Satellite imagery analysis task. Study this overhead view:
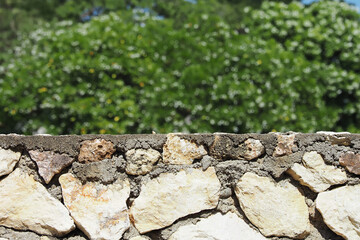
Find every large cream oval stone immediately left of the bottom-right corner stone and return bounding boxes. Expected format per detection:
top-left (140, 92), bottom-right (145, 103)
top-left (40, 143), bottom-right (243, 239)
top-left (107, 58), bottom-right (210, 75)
top-left (235, 172), bottom-right (310, 238)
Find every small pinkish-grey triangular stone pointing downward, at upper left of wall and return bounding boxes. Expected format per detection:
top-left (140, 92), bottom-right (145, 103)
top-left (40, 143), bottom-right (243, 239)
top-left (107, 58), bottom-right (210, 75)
top-left (29, 150), bottom-right (75, 183)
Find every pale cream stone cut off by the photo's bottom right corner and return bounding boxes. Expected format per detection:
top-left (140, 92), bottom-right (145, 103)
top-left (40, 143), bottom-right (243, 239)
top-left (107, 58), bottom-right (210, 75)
top-left (315, 185), bottom-right (360, 240)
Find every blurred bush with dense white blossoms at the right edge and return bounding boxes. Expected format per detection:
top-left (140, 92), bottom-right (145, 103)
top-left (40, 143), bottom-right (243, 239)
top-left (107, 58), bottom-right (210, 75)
top-left (244, 1), bottom-right (360, 131)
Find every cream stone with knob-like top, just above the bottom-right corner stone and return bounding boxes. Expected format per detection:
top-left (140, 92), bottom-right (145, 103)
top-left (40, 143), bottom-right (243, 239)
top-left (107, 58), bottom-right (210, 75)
top-left (288, 151), bottom-right (347, 192)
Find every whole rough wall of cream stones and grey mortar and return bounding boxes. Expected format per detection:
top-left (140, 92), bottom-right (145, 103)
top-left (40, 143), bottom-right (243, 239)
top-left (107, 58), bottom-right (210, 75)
top-left (0, 132), bottom-right (360, 240)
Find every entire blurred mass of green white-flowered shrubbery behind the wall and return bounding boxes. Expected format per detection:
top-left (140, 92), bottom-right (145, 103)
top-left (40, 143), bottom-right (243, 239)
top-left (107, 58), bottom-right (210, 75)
top-left (0, 0), bottom-right (360, 134)
